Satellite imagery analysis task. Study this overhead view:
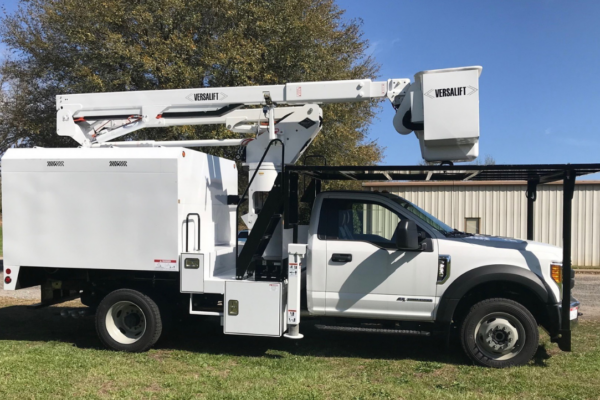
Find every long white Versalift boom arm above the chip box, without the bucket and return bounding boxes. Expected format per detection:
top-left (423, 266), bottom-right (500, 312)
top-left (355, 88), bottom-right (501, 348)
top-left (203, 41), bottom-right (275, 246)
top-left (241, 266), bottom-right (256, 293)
top-left (57, 79), bottom-right (410, 146)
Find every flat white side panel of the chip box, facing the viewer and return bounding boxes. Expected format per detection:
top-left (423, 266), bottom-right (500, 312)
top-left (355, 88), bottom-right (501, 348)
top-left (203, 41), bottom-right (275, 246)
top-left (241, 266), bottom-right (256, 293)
top-left (3, 149), bottom-right (179, 271)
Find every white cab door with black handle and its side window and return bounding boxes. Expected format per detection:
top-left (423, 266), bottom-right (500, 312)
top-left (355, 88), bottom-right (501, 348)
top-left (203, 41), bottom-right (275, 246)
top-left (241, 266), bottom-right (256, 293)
top-left (319, 194), bottom-right (438, 320)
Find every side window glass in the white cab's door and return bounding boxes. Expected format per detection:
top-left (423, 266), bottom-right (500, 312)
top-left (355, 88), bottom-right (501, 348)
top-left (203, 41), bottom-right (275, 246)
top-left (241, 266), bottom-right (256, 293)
top-left (317, 199), bottom-right (418, 248)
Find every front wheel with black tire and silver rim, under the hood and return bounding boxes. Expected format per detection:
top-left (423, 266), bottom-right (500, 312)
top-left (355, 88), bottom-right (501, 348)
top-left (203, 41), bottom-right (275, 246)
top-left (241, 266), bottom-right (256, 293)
top-left (461, 298), bottom-right (540, 368)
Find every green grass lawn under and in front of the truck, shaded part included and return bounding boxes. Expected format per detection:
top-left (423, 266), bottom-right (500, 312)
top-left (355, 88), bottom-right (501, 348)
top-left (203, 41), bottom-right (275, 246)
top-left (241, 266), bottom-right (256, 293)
top-left (0, 298), bottom-right (600, 399)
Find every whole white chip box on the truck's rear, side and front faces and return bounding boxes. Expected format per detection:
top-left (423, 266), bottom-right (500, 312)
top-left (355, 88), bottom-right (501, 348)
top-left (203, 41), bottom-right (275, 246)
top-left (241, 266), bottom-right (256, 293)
top-left (2, 147), bottom-right (237, 271)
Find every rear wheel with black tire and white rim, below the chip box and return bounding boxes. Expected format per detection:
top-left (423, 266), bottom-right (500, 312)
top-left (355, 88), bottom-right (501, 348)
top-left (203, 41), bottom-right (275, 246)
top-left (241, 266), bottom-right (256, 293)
top-left (96, 289), bottom-right (162, 353)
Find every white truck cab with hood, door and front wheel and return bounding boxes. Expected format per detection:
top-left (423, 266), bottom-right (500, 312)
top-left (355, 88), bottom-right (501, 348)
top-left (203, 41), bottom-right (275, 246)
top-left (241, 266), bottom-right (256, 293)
top-left (306, 191), bottom-right (577, 366)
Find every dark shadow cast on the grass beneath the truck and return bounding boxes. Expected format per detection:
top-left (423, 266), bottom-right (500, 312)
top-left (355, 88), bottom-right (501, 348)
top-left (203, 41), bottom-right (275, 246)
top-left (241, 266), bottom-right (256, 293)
top-left (0, 306), bottom-right (550, 366)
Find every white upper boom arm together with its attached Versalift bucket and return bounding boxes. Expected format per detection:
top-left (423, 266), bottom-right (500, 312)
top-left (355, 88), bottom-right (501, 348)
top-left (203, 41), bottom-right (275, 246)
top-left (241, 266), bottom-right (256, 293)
top-left (56, 67), bottom-right (482, 162)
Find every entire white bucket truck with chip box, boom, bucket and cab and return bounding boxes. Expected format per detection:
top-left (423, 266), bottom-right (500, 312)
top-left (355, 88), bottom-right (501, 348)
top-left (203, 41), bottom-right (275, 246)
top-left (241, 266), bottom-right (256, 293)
top-left (2, 67), bottom-right (577, 367)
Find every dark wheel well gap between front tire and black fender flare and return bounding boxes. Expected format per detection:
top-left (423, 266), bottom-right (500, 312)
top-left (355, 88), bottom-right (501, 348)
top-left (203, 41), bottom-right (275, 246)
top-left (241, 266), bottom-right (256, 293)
top-left (452, 281), bottom-right (548, 325)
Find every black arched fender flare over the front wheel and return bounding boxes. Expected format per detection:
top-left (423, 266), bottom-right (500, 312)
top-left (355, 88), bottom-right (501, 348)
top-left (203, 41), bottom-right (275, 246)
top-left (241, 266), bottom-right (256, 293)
top-left (436, 265), bottom-right (554, 323)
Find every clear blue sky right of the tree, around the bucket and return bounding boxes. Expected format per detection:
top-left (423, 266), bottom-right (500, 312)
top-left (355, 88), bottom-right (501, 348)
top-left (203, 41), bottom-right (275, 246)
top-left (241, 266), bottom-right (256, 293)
top-left (2, 0), bottom-right (600, 175)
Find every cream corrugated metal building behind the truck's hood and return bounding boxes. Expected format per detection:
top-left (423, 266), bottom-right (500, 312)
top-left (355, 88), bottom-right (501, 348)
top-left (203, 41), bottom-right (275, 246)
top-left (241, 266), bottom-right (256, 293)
top-left (363, 181), bottom-right (600, 267)
